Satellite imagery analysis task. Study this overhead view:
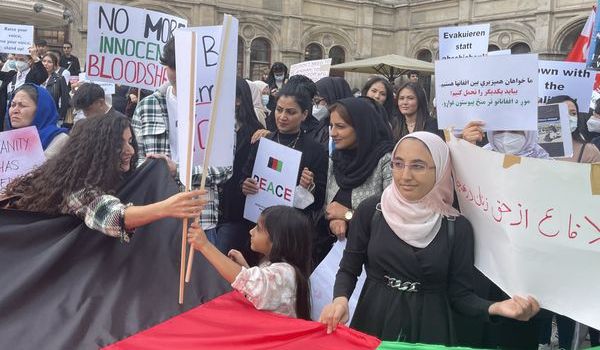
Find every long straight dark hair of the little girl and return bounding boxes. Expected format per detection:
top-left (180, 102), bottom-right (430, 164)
top-left (261, 205), bottom-right (313, 320)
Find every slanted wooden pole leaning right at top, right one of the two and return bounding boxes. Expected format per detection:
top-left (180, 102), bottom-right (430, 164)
top-left (185, 14), bottom-right (232, 282)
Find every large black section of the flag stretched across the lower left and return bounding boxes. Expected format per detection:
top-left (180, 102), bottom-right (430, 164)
top-left (0, 160), bottom-right (231, 350)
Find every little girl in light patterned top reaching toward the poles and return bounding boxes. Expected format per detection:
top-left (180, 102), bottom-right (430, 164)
top-left (188, 206), bottom-right (312, 320)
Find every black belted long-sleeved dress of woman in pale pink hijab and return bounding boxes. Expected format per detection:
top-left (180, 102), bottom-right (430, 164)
top-left (334, 196), bottom-right (491, 345)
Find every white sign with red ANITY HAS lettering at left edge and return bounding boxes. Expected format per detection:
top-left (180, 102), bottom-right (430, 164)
top-left (0, 126), bottom-right (46, 192)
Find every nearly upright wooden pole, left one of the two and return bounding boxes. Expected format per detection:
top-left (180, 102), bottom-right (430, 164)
top-left (179, 32), bottom-right (196, 304)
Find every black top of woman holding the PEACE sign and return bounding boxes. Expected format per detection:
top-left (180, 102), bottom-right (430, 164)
top-left (240, 131), bottom-right (329, 216)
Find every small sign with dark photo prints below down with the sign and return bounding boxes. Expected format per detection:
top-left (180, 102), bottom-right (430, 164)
top-left (537, 103), bottom-right (573, 157)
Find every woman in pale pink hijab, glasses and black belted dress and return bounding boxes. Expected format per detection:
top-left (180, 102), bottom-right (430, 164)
top-left (320, 132), bottom-right (539, 345)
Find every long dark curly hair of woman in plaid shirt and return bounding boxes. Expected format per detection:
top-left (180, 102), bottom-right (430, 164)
top-left (5, 113), bottom-right (137, 215)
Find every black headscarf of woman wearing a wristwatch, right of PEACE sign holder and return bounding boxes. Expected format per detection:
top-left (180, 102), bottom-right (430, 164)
top-left (332, 97), bottom-right (394, 190)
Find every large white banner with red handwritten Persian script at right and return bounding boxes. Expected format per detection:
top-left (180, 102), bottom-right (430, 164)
top-left (449, 133), bottom-right (600, 328)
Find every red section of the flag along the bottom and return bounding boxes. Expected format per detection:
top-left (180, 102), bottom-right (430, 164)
top-left (104, 291), bottom-right (381, 350)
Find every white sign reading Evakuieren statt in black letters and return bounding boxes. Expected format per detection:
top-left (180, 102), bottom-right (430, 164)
top-left (439, 23), bottom-right (490, 60)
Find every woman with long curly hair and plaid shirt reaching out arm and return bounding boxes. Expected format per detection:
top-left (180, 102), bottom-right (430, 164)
top-left (0, 115), bottom-right (205, 242)
